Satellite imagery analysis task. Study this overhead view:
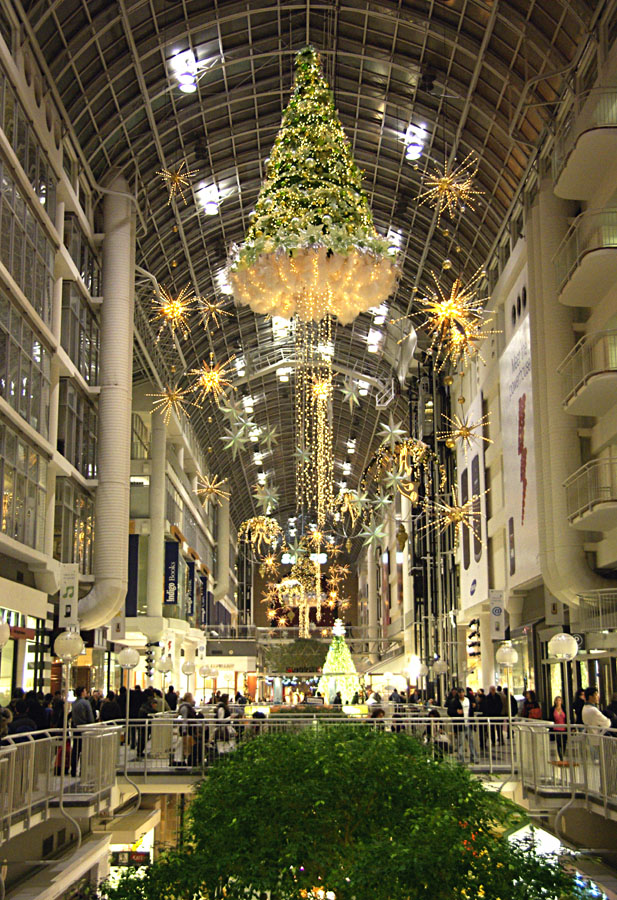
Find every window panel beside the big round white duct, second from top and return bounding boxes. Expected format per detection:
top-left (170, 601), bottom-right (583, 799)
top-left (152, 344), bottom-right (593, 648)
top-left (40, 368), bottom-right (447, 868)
top-left (61, 281), bottom-right (99, 385)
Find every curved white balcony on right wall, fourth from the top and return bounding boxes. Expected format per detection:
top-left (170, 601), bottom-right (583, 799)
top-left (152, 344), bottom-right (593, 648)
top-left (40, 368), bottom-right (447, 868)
top-left (564, 459), bottom-right (617, 532)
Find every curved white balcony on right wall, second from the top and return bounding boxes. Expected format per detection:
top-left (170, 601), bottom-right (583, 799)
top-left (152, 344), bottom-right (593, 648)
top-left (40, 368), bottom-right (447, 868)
top-left (553, 208), bottom-right (617, 306)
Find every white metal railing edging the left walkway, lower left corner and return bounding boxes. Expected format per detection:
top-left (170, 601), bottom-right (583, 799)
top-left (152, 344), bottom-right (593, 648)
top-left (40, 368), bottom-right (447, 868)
top-left (0, 725), bottom-right (122, 839)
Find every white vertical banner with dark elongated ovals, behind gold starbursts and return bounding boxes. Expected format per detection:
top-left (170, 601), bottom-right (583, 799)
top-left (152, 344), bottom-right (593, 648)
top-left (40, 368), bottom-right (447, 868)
top-left (456, 391), bottom-right (488, 610)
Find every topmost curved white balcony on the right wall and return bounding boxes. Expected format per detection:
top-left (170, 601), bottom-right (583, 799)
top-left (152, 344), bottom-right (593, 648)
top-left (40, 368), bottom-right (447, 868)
top-left (553, 87), bottom-right (617, 200)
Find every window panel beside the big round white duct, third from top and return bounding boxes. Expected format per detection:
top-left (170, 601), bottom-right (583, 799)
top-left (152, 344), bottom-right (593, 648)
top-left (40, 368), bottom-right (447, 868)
top-left (58, 378), bottom-right (98, 478)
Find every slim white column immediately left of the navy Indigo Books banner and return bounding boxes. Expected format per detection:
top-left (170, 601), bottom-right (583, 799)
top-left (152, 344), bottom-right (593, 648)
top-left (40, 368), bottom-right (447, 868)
top-left (146, 412), bottom-right (167, 616)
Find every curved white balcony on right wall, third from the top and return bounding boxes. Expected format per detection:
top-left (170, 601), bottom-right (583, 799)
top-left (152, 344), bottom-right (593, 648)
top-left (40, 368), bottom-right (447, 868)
top-left (558, 330), bottom-right (617, 416)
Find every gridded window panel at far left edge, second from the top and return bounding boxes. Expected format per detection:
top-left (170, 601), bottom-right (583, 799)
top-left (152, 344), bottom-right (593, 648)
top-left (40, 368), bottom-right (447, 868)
top-left (0, 157), bottom-right (54, 325)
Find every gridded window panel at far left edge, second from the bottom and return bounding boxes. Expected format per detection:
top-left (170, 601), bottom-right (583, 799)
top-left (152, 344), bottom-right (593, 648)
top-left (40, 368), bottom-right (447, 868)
top-left (0, 286), bottom-right (51, 437)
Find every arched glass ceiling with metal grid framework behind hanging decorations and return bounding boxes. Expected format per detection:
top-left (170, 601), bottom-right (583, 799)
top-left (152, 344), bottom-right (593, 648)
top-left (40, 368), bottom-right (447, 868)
top-left (21, 0), bottom-right (606, 523)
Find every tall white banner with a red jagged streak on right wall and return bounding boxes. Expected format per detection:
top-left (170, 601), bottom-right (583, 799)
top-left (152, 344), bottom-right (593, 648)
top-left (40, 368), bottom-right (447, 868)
top-left (499, 316), bottom-right (540, 587)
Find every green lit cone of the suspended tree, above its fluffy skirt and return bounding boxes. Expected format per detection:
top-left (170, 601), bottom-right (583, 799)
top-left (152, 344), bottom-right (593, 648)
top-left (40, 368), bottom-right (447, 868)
top-left (229, 47), bottom-right (389, 267)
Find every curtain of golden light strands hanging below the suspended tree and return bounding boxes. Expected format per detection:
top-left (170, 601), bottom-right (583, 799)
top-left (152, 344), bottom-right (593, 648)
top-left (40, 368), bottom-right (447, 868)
top-left (294, 316), bottom-right (334, 529)
